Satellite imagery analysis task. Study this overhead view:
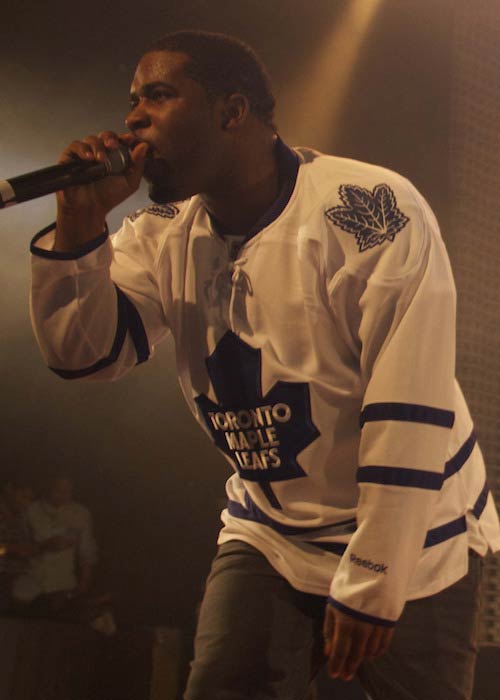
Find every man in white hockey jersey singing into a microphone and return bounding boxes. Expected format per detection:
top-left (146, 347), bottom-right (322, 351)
top-left (32, 31), bottom-right (500, 700)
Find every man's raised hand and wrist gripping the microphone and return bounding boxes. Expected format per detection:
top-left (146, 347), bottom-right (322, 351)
top-left (54, 131), bottom-right (149, 252)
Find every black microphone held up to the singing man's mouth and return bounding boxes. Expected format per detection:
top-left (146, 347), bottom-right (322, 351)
top-left (0, 144), bottom-right (131, 209)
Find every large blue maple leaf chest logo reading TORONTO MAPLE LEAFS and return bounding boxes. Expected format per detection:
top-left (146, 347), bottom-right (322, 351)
top-left (195, 331), bottom-right (320, 482)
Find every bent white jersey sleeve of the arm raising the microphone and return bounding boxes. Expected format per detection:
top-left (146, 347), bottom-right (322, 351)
top-left (30, 215), bottom-right (168, 380)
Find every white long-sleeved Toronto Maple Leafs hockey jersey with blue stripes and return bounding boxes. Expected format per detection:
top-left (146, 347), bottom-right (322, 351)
top-left (32, 143), bottom-right (500, 626)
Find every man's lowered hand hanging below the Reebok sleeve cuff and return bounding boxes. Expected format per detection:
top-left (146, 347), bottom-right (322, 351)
top-left (323, 605), bottom-right (394, 681)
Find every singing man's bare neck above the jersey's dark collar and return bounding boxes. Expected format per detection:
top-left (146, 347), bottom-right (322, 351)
top-left (201, 133), bottom-right (279, 235)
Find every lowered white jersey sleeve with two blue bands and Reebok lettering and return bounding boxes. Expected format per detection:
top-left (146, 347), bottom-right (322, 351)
top-left (329, 183), bottom-right (455, 626)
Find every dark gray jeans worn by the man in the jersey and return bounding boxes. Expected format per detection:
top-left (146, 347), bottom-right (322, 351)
top-left (184, 541), bottom-right (482, 700)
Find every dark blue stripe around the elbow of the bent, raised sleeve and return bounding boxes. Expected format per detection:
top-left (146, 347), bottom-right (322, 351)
top-left (50, 285), bottom-right (149, 379)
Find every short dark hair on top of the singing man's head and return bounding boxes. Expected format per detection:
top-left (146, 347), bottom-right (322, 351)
top-left (146, 30), bottom-right (275, 126)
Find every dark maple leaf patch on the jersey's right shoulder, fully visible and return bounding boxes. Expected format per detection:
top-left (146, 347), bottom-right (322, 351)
top-left (325, 184), bottom-right (410, 253)
